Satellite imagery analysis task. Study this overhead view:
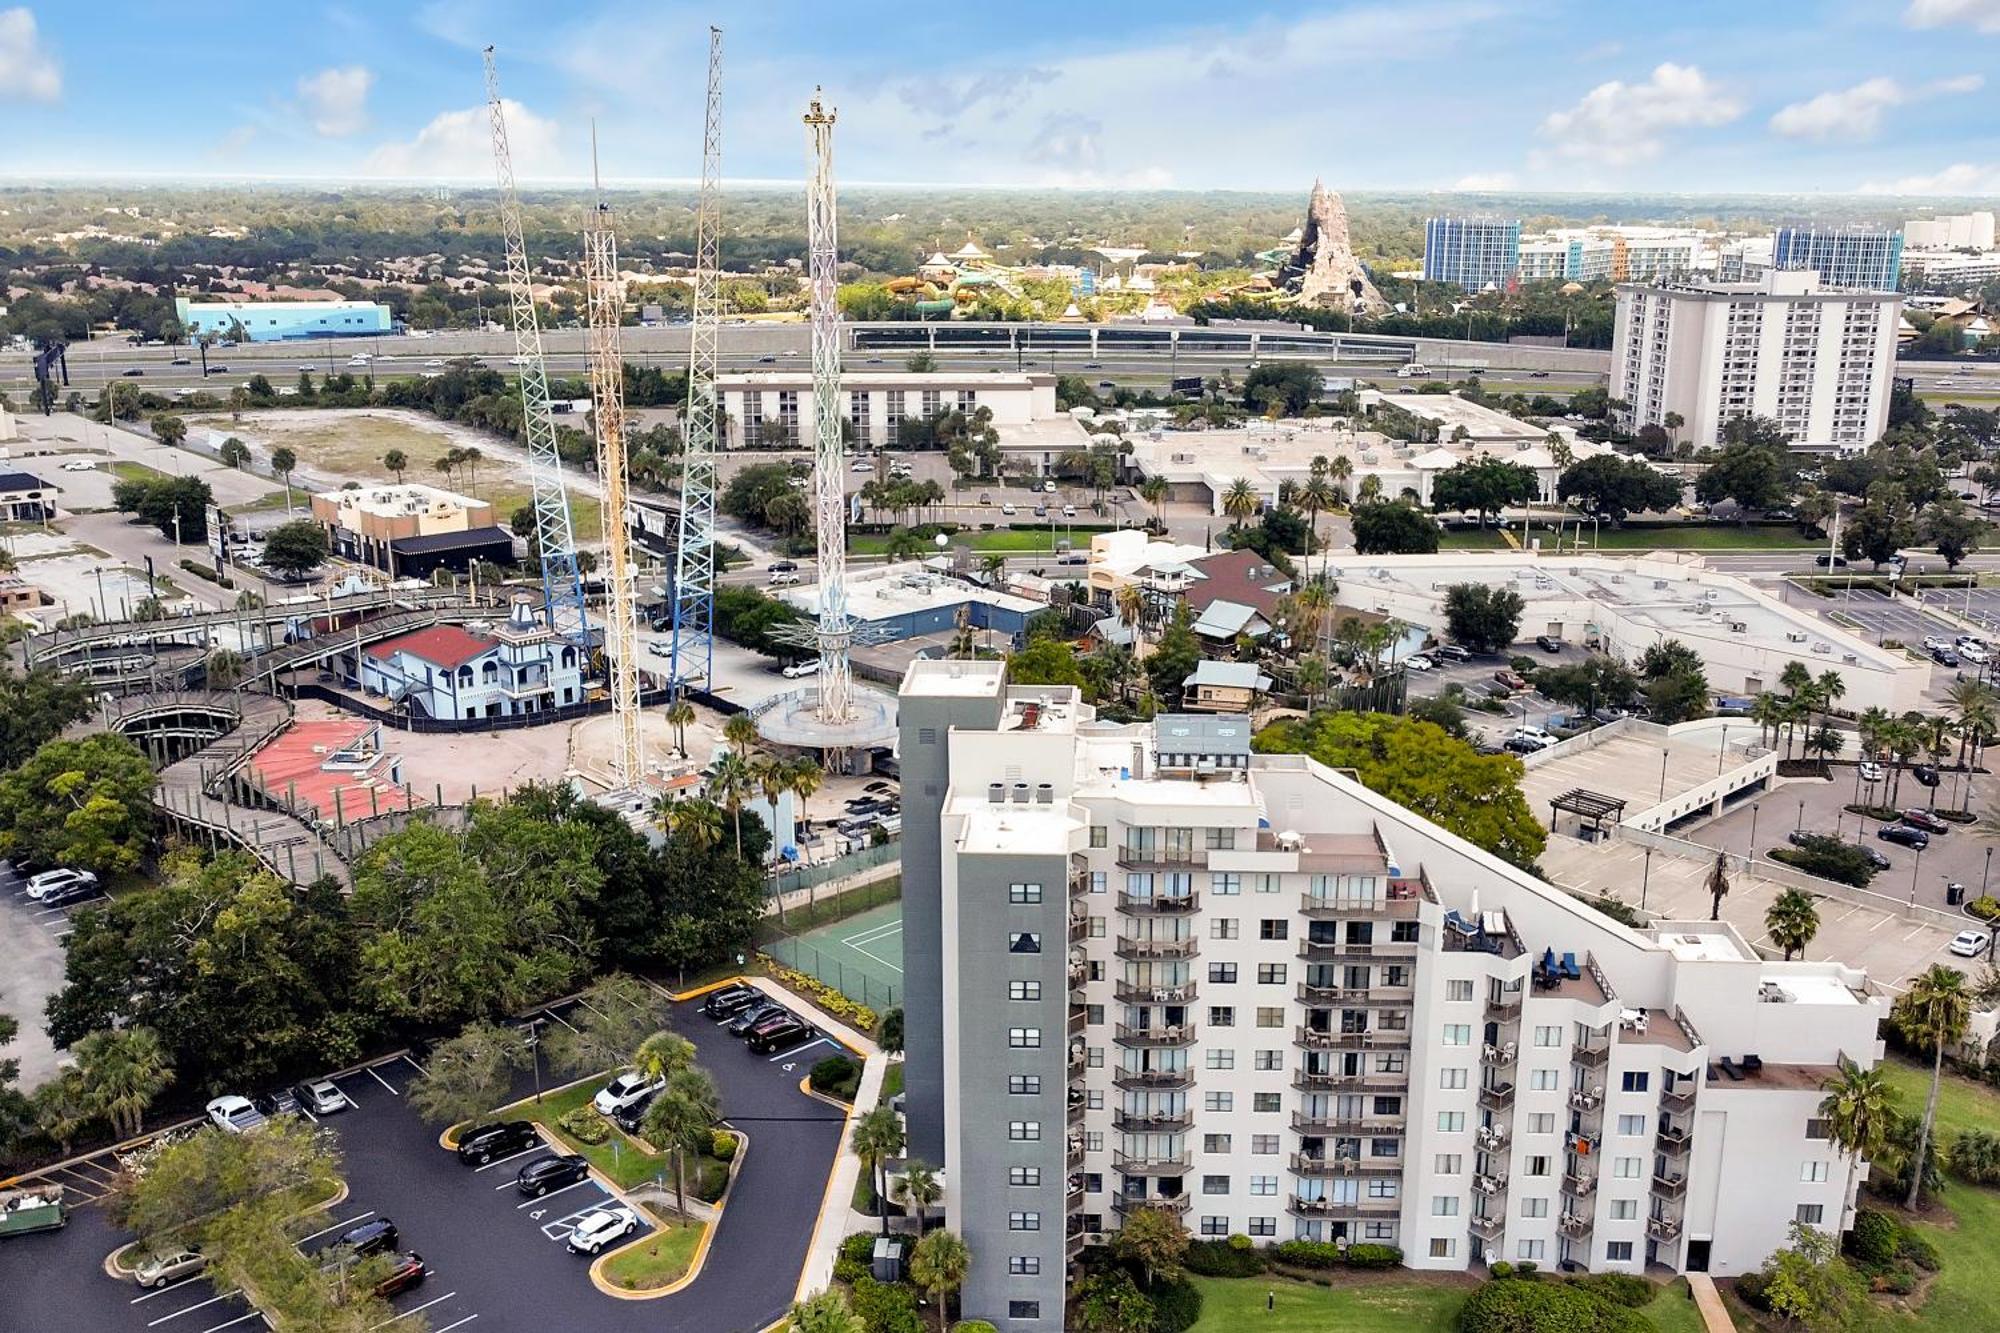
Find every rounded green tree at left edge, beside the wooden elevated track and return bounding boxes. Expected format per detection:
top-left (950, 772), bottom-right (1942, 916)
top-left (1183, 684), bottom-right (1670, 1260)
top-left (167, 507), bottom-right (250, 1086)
top-left (0, 733), bottom-right (156, 875)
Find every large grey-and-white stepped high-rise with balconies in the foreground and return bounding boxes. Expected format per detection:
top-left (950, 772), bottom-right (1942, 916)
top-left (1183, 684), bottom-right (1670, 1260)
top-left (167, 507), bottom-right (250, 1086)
top-left (900, 660), bottom-right (1882, 1331)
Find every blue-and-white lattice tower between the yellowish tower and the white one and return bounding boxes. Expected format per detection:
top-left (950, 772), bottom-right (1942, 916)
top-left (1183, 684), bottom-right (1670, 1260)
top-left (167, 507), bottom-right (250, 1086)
top-left (668, 28), bottom-right (722, 691)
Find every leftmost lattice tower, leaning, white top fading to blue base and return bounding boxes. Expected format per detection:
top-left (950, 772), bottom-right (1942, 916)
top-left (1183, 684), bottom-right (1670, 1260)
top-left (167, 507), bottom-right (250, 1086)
top-left (486, 46), bottom-right (584, 642)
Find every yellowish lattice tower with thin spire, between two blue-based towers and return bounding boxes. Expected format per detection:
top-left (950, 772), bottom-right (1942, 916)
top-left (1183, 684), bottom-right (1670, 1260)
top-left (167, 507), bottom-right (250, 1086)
top-left (584, 126), bottom-right (644, 789)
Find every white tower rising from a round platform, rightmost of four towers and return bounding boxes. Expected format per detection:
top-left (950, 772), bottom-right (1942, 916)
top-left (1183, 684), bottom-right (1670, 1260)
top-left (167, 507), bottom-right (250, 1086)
top-left (806, 88), bottom-right (854, 723)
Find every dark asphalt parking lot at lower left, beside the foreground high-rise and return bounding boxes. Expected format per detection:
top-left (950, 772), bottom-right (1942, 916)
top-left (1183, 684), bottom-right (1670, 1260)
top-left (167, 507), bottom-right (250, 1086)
top-left (0, 980), bottom-right (844, 1333)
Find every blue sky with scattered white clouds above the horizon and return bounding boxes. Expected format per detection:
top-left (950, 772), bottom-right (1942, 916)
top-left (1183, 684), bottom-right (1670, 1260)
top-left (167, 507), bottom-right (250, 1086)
top-left (0, 0), bottom-right (2000, 194)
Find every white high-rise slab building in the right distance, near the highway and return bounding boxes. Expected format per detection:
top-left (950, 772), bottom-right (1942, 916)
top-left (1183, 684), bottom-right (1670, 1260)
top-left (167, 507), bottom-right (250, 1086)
top-left (1610, 272), bottom-right (1902, 448)
